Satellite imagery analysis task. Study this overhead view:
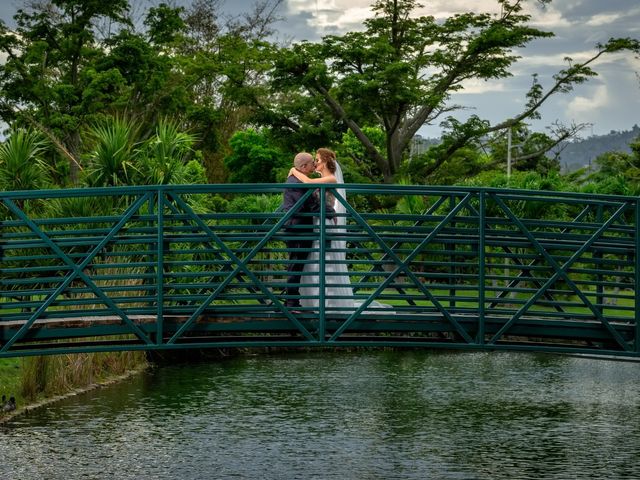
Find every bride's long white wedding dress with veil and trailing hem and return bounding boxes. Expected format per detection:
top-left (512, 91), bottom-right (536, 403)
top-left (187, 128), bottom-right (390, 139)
top-left (300, 162), bottom-right (391, 313)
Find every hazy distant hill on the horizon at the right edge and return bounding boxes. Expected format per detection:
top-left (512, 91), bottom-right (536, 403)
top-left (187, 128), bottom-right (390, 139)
top-left (560, 125), bottom-right (640, 172)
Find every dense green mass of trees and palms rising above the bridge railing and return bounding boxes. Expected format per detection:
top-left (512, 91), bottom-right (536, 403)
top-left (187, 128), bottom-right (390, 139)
top-left (0, 0), bottom-right (639, 189)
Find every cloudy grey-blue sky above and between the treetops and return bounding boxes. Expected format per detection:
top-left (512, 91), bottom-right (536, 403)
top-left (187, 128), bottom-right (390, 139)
top-left (0, 0), bottom-right (640, 137)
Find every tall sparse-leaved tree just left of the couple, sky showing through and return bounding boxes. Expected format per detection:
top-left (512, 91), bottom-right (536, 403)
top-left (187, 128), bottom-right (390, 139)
top-left (181, 0), bottom-right (284, 182)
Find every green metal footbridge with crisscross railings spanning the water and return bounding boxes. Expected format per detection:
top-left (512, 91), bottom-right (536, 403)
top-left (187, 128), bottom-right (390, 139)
top-left (0, 184), bottom-right (640, 357)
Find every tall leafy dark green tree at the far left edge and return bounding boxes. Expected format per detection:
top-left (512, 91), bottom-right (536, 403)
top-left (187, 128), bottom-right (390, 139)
top-left (0, 0), bottom-right (129, 182)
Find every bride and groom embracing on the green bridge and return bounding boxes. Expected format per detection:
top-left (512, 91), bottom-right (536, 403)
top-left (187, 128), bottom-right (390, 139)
top-left (283, 148), bottom-right (386, 313)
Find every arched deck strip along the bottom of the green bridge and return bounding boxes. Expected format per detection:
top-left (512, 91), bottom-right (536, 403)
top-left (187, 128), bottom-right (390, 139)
top-left (0, 313), bottom-right (635, 355)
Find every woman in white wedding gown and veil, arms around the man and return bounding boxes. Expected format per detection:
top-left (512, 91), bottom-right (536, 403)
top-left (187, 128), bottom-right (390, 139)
top-left (289, 148), bottom-right (390, 313)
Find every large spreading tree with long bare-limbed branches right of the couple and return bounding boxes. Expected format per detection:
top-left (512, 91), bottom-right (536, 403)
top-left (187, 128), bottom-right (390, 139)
top-left (274, 0), bottom-right (640, 181)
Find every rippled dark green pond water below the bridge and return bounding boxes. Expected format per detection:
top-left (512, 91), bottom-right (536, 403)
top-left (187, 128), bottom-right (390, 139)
top-left (0, 351), bottom-right (640, 479)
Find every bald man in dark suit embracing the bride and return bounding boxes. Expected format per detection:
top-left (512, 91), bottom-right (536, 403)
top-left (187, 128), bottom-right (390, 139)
top-left (282, 152), bottom-right (320, 308)
